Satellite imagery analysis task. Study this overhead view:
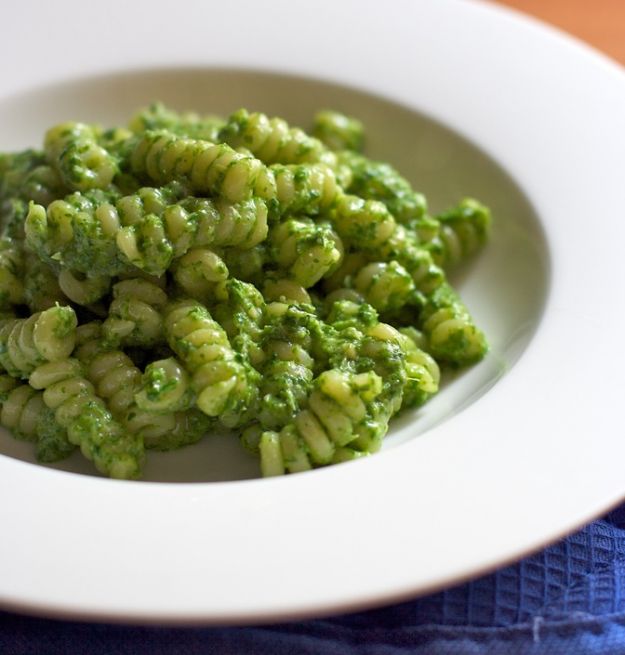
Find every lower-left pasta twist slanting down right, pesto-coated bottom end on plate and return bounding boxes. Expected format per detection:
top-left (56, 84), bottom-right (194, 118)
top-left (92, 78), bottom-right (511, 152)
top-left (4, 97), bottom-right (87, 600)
top-left (29, 358), bottom-right (144, 479)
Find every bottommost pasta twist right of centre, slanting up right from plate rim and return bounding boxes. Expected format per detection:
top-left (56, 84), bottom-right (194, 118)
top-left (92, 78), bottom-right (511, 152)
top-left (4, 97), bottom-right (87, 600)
top-left (259, 369), bottom-right (386, 476)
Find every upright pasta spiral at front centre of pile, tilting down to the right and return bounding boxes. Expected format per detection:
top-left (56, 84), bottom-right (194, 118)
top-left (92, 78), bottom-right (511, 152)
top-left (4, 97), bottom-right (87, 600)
top-left (164, 300), bottom-right (258, 427)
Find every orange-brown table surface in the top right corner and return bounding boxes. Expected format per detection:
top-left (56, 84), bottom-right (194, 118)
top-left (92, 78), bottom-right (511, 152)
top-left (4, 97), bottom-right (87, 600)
top-left (498, 0), bottom-right (625, 64)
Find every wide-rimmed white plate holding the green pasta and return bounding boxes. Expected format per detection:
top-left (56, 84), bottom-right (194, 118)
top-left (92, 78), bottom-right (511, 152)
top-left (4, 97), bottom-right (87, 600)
top-left (0, 0), bottom-right (625, 623)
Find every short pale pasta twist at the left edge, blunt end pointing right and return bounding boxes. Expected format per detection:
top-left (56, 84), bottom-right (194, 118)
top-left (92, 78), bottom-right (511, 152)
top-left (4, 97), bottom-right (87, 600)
top-left (0, 306), bottom-right (77, 378)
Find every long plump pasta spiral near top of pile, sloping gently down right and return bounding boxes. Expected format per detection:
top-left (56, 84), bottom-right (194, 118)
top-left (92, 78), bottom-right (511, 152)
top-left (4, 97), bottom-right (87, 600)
top-left (130, 130), bottom-right (276, 203)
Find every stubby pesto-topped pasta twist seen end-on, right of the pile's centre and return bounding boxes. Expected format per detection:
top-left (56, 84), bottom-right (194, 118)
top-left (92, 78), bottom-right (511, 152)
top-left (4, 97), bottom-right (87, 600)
top-left (269, 218), bottom-right (343, 288)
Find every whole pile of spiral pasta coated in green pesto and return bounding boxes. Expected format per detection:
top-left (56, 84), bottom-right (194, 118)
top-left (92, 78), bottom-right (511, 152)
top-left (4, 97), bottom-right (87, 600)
top-left (0, 103), bottom-right (491, 479)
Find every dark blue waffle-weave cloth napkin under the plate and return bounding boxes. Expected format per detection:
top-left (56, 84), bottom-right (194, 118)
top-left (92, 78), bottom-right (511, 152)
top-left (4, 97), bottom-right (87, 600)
top-left (6, 505), bottom-right (625, 655)
